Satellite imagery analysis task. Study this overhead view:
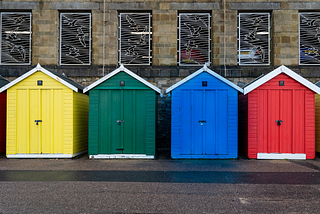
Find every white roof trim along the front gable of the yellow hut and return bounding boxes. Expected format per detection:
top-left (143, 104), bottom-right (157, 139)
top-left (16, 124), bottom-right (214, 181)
top-left (0, 63), bottom-right (78, 93)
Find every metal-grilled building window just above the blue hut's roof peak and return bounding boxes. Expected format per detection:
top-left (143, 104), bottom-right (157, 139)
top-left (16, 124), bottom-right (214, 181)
top-left (178, 13), bottom-right (211, 66)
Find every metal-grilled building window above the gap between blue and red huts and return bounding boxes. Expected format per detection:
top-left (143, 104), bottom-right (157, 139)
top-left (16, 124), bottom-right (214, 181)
top-left (238, 13), bottom-right (270, 65)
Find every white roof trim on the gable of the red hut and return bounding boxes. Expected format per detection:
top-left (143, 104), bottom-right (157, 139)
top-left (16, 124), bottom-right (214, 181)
top-left (244, 65), bottom-right (320, 94)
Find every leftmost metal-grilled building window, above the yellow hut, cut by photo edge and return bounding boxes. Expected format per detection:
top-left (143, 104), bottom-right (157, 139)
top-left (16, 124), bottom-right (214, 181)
top-left (0, 12), bottom-right (32, 65)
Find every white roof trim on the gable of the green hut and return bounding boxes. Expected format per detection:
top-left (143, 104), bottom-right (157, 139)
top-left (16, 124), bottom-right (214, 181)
top-left (83, 64), bottom-right (161, 94)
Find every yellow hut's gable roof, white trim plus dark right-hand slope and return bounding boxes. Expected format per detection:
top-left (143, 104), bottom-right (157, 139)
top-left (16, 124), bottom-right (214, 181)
top-left (0, 63), bottom-right (83, 92)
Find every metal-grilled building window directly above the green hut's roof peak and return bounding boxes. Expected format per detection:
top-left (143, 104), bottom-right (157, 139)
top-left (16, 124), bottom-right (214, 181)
top-left (119, 13), bottom-right (152, 65)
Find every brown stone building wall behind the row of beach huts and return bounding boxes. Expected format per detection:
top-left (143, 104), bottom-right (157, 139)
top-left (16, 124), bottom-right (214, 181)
top-left (0, 0), bottom-right (320, 148)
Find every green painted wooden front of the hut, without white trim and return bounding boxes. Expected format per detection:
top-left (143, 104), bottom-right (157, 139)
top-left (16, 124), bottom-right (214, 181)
top-left (89, 72), bottom-right (156, 155)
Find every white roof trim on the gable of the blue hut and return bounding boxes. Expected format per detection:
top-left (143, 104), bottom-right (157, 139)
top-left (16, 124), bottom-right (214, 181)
top-left (166, 64), bottom-right (243, 94)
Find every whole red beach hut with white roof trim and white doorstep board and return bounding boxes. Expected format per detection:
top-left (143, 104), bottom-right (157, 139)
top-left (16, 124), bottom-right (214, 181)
top-left (239, 65), bottom-right (320, 159)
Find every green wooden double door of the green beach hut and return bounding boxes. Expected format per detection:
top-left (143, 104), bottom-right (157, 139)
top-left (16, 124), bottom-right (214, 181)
top-left (98, 90), bottom-right (146, 154)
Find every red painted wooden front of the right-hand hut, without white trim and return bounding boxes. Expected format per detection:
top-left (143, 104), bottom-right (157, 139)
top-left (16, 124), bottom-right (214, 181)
top-left (245, 74), bottom-right (315, 159)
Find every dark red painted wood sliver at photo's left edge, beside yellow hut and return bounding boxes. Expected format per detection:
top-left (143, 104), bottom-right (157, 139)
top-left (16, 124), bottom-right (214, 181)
top-left (0, 92), bottom-right (7, 153)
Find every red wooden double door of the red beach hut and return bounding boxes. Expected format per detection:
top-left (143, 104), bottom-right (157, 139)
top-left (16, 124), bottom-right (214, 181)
top-left (258, 89), bottom-right (305, 153)
